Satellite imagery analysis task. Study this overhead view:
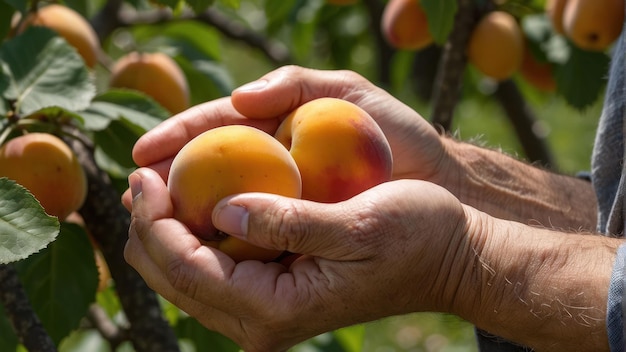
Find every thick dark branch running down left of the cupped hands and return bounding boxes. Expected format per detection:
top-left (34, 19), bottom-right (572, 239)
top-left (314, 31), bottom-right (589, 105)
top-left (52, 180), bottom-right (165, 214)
top-left (70, 140), bottom-right (179, 352)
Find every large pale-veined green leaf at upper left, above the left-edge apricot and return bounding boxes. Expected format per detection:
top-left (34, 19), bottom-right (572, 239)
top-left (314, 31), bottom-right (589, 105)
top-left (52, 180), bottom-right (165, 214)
top-left (0, 26), bottom-right (95, 114)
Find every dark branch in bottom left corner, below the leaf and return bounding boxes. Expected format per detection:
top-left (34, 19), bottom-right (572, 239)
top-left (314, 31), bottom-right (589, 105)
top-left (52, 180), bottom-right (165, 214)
top-left (0, 264), bottom-right (57, 352)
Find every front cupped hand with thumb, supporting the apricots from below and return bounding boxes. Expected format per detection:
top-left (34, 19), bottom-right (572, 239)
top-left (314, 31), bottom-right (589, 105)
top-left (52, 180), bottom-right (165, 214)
top-left (124, 168), bottom-right (471, 352)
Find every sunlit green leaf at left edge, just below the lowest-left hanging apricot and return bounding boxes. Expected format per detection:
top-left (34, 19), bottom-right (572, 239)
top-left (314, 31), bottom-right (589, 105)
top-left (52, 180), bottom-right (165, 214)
top-left (0, 177), bottom-right (59, 264)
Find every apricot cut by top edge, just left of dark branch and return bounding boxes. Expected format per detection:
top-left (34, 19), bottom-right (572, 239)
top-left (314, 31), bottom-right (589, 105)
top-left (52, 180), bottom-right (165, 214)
top-left (381, 0), bottom-right (433, 50)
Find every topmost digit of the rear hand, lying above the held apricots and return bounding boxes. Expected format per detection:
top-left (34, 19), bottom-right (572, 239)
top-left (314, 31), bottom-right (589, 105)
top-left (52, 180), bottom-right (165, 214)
top-left (232, 66), bottom-right (369, 119)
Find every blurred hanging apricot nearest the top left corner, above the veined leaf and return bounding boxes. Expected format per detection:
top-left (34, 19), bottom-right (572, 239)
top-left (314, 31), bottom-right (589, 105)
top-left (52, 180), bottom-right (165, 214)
top-left (17, 4), bottom-right (100, 68)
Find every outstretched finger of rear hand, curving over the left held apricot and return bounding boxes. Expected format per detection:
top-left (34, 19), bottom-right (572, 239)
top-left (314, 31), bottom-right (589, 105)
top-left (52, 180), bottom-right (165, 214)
top-left (132, 98), bottom-right (278, 166)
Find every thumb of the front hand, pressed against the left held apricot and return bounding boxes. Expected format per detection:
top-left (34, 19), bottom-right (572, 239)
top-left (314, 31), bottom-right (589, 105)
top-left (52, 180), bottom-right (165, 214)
top-left (212, 193), bottom-right (360, 260)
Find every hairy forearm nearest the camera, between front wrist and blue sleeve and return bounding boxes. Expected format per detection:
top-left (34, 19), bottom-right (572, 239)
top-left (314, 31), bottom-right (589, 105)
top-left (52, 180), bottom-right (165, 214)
top-left (455, 207), bottom-right (623, 351)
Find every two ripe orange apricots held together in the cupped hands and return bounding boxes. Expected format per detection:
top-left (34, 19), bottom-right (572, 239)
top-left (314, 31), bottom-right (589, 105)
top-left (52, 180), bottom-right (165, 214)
top-left (167, 98), bottom-right (392, 262)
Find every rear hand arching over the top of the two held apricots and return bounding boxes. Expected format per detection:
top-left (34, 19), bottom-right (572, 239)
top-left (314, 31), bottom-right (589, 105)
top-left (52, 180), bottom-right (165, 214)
top-left (123, 66), bottom-right (445, 209)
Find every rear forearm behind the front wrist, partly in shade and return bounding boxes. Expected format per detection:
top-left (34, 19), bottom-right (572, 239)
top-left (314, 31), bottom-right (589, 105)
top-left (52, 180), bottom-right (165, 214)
top-left (441, 138), bottom-right (597, 231)
